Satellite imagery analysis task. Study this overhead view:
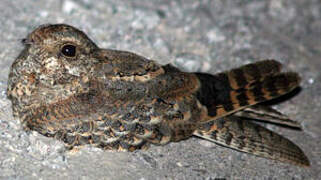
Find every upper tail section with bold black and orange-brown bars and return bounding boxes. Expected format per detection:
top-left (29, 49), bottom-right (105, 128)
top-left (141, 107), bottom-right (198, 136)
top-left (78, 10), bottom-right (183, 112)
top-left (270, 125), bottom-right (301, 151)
top-left (196, 60), bottom-right (300, 119)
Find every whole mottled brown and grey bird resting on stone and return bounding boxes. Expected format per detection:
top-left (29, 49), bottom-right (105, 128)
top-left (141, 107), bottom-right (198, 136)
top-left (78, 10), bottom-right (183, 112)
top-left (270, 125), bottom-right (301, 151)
top-left (7, 24), bottom-right (309, 165)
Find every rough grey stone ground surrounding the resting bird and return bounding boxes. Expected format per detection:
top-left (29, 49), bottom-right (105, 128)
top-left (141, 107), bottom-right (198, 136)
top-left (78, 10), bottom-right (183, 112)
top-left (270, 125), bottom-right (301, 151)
top-left (0, 0), bottom-right (321, 179)
